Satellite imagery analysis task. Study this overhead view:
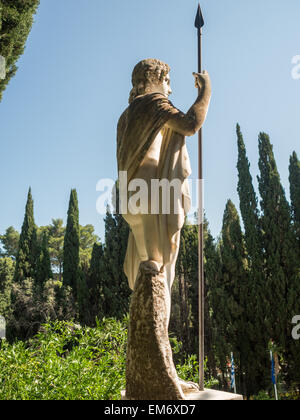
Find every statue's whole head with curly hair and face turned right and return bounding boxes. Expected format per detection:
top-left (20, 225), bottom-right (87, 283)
top-left (129, 58), bottom-right (172, 103)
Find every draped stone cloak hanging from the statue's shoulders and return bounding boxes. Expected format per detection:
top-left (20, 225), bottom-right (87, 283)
top-left (117, 93), bottom-right (191, 290)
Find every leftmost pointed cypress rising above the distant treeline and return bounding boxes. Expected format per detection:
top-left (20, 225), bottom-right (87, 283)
top-left (14, 188), bottom-right (38, 283)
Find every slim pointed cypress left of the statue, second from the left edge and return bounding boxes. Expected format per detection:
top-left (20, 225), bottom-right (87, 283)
top-left (63, 189), bottom-right (80, 297)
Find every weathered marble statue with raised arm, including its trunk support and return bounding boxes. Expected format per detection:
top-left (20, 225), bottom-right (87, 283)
top-left (117, 59), bottom-right (211, 400)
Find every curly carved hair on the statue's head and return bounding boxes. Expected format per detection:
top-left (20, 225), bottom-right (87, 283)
top-left (129, 58), bottom-right (170, 103)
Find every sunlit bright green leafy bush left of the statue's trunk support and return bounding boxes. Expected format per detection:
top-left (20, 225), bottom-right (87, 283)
top-left (0, 319), bottom-right (127, 400)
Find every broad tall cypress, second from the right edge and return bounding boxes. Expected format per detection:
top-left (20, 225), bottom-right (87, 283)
top-left (258, 133), bottom-right (297, 351)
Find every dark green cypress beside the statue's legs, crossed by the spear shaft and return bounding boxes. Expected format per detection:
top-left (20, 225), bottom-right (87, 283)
top-left (170, 219), bottom-right (219, 375)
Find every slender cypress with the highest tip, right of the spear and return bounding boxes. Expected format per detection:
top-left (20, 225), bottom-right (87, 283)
top-left (237, 125), bottom-right (269, 393)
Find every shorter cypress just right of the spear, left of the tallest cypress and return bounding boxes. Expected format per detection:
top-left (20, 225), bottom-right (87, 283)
top-left (218, 200), bottom-right (253, 393)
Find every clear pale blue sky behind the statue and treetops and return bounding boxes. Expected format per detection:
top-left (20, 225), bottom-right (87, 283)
top-left (0, 0), bottom-right (300, 239)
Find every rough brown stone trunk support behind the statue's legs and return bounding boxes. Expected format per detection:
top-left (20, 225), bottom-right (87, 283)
top-left (125, 273), bottom-right (185, 400)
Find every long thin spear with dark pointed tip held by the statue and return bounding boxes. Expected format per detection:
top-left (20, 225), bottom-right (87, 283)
top-left (195, 3), bottom-right (204, 391)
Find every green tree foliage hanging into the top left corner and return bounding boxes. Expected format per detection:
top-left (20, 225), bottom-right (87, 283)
top-left (0, 0), bottom-right (39, 102)
